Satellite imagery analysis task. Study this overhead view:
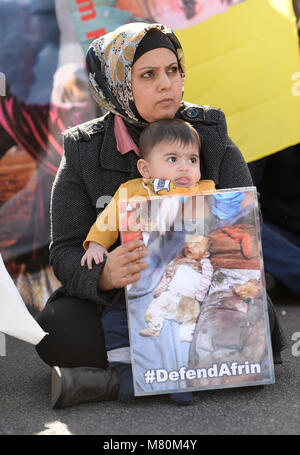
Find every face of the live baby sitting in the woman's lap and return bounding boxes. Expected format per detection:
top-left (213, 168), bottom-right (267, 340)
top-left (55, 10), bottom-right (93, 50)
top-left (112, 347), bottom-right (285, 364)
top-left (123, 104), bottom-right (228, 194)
top-left (140, 142), bottom-right (201, 188)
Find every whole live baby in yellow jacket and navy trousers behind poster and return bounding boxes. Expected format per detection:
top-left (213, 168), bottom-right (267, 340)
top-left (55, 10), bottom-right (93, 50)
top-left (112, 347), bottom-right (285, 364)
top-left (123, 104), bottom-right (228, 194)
top-left (81, 119), bottom-right (215, 404)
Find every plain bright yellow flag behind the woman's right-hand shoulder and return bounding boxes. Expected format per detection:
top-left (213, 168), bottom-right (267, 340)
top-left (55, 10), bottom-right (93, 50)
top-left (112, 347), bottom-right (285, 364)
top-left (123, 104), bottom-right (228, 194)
top-left (176, 0), bottom-right (300, 162)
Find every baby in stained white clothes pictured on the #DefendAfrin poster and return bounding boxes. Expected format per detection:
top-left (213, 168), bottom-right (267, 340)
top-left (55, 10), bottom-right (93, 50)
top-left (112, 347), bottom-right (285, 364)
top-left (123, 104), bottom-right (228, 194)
top-left (139, 235), bottom-right (213, 342)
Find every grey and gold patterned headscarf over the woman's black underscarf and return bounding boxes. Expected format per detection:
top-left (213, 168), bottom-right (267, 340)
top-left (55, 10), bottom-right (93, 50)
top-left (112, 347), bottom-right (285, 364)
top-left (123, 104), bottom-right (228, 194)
top-left (86, 22), bottom-right (185, 125)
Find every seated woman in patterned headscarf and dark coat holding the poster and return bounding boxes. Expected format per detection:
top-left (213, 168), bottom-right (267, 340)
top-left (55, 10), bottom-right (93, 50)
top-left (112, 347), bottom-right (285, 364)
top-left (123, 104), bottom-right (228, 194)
top-left (37, 23), bottom-right (283, 407)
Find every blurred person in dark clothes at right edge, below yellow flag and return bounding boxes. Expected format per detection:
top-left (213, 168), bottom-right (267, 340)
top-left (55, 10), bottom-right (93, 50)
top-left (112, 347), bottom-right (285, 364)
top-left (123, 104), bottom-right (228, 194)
top-left (248, 0), bottom-right (300, 296)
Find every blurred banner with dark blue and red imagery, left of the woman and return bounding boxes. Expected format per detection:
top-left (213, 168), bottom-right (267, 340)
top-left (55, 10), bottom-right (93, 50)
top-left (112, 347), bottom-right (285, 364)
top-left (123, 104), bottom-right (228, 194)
top-left (0, 0), bottom-right (99, 311)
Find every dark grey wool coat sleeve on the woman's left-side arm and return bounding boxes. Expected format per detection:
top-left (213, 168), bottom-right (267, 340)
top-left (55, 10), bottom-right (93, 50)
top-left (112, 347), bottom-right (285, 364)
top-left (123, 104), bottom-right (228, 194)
top-left (50, 128), bottom-right (120, 307)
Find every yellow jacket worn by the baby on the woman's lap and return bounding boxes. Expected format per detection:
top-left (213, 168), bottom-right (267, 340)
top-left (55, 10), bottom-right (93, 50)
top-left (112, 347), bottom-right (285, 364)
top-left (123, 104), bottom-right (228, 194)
top-left (83, 178), bottom-right (215, 249)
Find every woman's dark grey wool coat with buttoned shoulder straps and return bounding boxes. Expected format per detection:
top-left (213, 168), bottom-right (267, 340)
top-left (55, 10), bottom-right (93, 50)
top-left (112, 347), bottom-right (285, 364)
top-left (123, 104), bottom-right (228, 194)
top-left (50, 103), bottom-right (252, 311)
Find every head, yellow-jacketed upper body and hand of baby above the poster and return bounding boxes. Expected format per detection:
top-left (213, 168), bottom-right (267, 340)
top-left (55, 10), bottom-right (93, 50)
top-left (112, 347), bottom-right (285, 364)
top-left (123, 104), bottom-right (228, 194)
top-left (81, 119), bottom-right (215, 268)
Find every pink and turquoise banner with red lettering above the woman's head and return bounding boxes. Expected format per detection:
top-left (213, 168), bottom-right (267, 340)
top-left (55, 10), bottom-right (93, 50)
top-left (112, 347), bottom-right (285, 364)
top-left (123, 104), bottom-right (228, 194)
top-left (67, 0), bottom-right (245, 52)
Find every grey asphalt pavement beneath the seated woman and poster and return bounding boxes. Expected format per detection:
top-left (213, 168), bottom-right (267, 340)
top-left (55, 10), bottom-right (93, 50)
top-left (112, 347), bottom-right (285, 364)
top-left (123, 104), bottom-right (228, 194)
top-left (0, 291), bottom-right (300, 439)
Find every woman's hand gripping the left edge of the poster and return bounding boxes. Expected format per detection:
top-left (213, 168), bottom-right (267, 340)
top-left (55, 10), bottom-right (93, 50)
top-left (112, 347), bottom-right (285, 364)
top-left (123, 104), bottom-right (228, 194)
top-left (98, 240), bottom-right (148, 291)
